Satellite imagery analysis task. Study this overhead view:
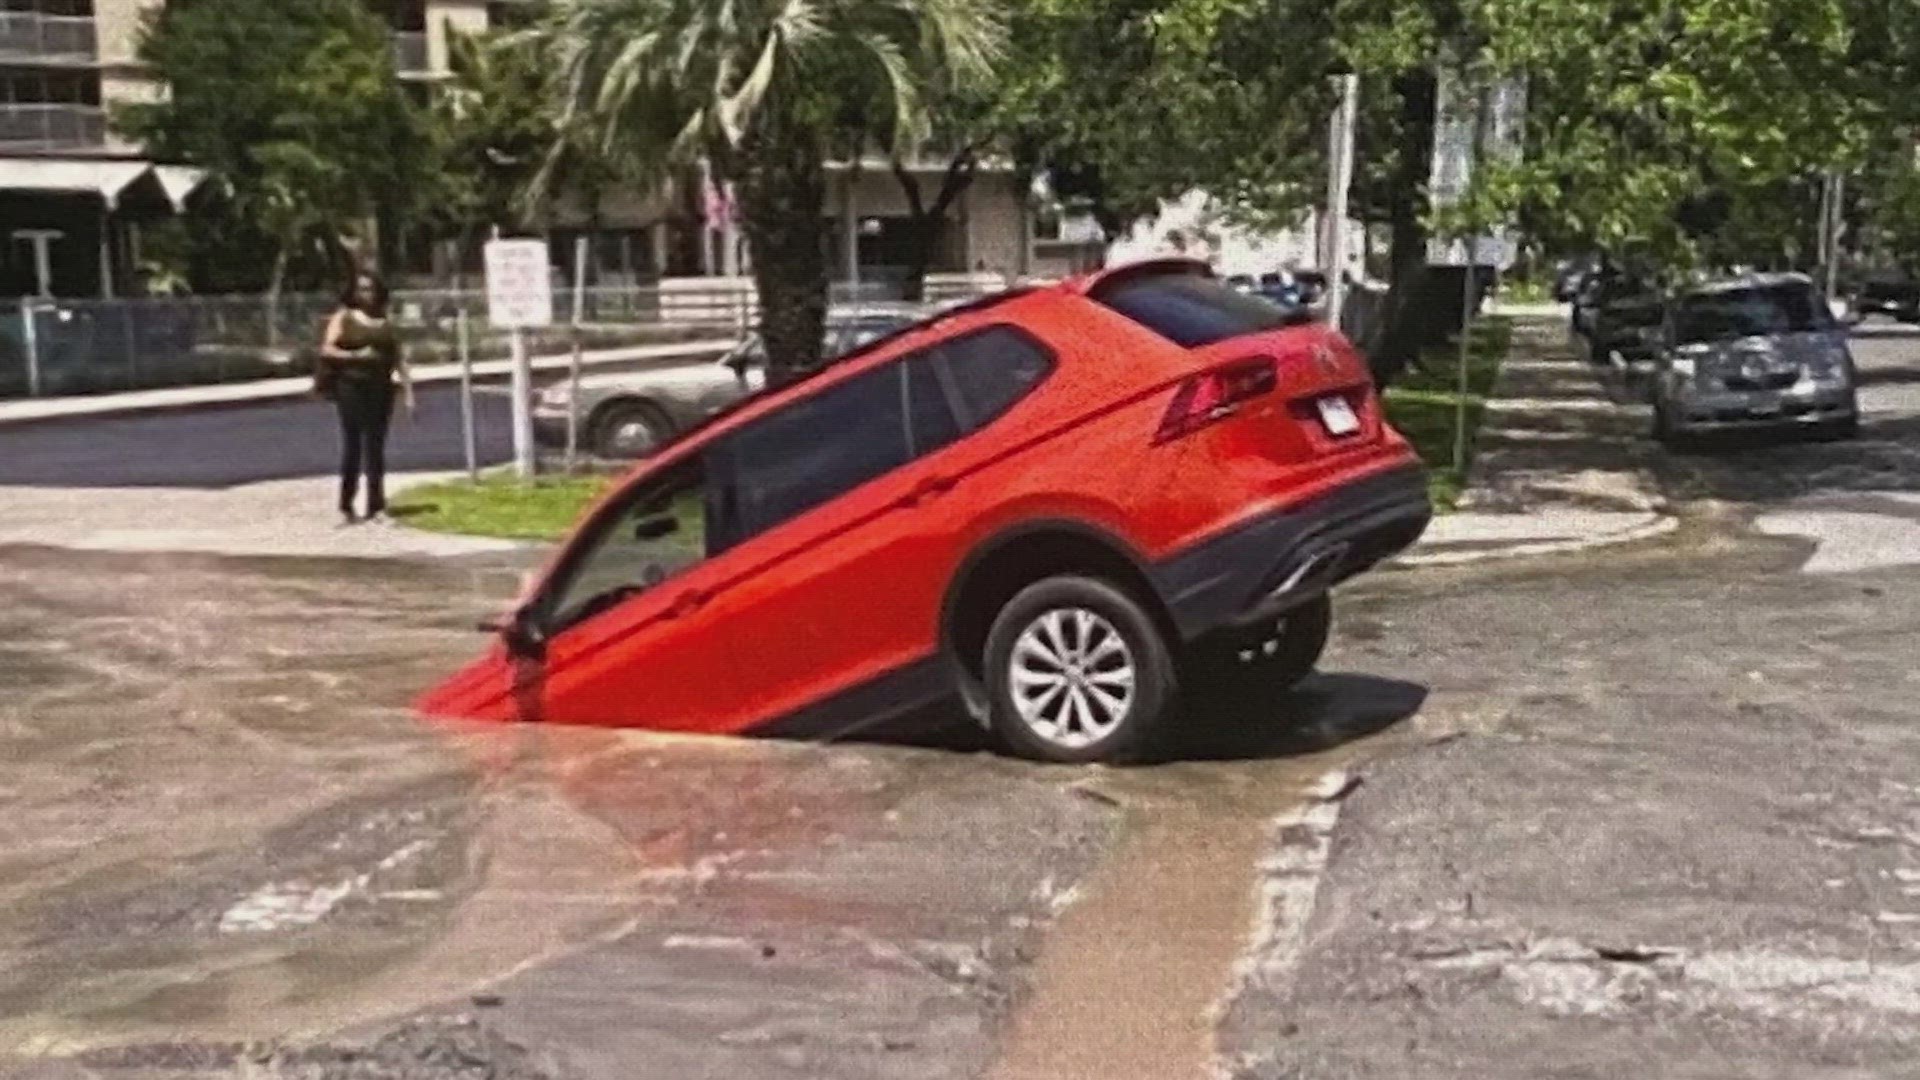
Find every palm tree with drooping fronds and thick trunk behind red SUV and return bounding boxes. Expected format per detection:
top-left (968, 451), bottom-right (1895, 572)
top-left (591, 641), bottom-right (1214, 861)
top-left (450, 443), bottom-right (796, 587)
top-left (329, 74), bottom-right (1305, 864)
top-left (547, 0), bottom-right (1004, 375)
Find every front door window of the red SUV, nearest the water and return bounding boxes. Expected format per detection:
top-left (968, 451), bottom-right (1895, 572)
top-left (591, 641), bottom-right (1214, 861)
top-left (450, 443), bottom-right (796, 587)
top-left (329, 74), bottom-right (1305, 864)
top-left (538, 457), bottom-right (726, 632)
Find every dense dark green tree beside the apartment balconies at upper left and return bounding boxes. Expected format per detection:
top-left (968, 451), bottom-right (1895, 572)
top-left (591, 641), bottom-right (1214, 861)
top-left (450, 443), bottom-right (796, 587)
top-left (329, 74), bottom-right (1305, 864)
top-left (113, 0), bottom-right (424, 307)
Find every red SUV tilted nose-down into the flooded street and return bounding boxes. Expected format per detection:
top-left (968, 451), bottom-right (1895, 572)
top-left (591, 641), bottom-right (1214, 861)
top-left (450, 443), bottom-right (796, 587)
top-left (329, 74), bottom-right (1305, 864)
top-left (420, 259), bottom-right (1430, 761)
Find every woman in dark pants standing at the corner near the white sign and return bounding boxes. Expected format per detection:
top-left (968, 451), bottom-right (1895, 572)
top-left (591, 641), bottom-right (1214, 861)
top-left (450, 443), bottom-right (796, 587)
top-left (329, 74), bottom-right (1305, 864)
top-left (321, 273), bottom-right (415, 525)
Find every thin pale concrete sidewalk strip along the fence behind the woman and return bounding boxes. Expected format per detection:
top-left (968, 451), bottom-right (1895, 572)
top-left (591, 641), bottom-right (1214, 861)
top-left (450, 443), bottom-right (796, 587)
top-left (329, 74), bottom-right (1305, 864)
top-left (0, 338), bottom-right (737, 425)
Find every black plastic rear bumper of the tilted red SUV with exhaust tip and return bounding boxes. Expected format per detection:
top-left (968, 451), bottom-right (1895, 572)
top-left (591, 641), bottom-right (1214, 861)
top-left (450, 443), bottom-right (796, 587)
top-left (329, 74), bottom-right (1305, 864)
top-left (1150, 465), bottom-right (1432, 642)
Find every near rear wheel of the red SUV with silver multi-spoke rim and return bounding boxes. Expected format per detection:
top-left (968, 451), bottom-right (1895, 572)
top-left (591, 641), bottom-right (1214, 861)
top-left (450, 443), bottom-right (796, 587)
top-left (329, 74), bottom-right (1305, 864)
top-left (983, 577), bottom-right (1179, 765)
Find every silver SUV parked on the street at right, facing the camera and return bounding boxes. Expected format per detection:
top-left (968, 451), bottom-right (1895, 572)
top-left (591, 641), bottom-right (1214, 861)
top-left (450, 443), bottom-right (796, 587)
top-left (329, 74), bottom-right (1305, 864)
top-left (1653, 275), bottom-right (1860, 442)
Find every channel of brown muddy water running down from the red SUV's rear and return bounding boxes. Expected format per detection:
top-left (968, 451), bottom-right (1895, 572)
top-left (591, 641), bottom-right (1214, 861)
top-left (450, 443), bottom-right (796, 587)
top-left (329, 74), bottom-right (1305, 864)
top-left (989, 668), bottom-right (1425, 1080)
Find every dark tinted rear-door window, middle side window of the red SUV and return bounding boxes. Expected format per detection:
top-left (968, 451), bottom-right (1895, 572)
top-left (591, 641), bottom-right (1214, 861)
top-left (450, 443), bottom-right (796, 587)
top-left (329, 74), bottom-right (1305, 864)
top-left (728, 363), bottom-right (912, 538)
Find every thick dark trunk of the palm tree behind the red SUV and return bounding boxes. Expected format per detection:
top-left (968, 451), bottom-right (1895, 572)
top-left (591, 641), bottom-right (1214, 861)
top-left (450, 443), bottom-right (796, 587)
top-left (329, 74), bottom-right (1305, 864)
top-left (730, 108), bottom-right (828, 382)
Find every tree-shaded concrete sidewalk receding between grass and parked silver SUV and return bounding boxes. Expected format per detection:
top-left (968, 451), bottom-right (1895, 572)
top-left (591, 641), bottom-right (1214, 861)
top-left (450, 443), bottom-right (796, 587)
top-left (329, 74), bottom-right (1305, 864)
top-left (1400, 315), bottom-right (1676, 565)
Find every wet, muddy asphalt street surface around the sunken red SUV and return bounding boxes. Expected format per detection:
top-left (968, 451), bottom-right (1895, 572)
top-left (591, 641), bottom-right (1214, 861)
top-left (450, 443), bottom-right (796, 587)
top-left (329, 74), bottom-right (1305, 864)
top-left (0, 320), bottom-right (1920, 1080)
